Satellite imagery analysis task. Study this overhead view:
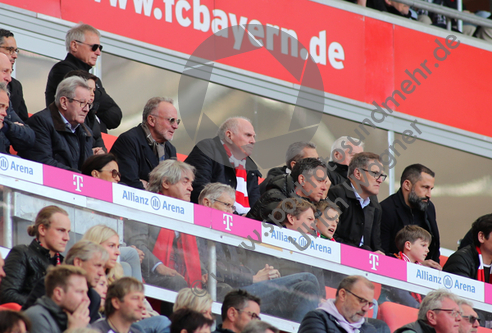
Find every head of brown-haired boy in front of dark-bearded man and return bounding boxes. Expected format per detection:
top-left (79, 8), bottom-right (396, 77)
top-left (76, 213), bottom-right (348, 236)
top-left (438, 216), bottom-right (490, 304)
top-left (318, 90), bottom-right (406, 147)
top-left (395, 225), bottom-right (432, 265)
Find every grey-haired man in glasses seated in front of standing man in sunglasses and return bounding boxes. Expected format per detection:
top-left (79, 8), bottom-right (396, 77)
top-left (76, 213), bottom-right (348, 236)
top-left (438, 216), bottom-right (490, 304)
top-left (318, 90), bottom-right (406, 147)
top-left (18, 76), bottom-right (93, 171)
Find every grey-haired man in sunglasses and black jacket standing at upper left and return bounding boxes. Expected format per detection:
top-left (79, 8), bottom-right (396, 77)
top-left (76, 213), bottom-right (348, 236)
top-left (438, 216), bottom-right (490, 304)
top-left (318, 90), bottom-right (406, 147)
top-left (45, 24), bottom-right (123, 133)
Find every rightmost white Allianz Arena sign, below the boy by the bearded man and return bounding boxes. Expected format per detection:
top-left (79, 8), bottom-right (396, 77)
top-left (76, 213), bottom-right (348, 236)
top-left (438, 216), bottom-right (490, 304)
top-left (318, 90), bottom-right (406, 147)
top-left (407, 263), bottom-right (484, 302)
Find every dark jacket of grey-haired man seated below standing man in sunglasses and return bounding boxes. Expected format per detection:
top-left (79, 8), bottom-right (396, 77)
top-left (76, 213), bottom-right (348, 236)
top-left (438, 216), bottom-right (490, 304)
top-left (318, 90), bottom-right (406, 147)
top-left (18, 103), bottom-right (93, 171)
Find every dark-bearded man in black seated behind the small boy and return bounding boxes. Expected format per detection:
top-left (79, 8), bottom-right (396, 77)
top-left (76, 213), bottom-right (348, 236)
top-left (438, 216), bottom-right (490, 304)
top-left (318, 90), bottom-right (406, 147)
top-left (381, 164), bottom-right (441, 270)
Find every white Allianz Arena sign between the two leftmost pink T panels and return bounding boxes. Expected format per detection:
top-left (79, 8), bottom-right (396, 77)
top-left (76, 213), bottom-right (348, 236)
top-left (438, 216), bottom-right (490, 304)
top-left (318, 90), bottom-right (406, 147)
top-left (113, 184), bottom-right (194, 223)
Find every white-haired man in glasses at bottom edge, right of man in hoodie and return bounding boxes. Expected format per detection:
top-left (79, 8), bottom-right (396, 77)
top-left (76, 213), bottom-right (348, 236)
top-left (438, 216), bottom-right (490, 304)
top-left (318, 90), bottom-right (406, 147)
top-left (394, 289), bottom-right (463, 333)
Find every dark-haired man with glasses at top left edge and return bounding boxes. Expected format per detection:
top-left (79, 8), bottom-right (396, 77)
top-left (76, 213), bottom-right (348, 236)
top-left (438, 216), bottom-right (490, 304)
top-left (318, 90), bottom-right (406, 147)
top-left (0, 29), bottom-right (29, 122)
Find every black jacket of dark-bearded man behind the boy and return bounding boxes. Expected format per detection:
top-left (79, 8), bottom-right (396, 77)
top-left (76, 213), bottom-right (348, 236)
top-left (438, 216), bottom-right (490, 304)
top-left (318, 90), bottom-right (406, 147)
top-left (381, 188), bottom-right (441, 263)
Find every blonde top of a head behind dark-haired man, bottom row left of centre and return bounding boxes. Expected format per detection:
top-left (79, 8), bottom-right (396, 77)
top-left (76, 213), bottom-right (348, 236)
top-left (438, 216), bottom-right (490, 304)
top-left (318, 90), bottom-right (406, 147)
top-left (173, 288), bottom-right (214, 319)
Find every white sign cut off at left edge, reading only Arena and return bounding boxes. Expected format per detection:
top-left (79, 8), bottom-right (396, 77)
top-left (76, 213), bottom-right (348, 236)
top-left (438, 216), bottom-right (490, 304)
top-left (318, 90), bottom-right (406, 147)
top-left (0, 154), bottom-right (43, 184)
